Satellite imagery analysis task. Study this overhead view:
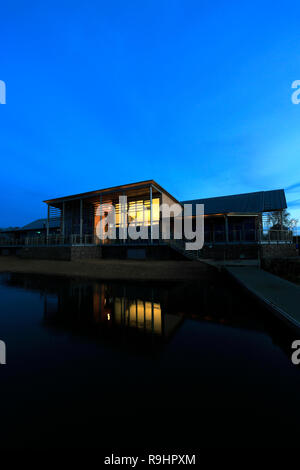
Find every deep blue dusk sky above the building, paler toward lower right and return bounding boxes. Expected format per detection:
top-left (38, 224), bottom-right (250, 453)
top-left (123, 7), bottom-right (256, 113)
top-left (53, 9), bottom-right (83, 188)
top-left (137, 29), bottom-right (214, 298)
top-left (0, 0), bottom-right (300, 227)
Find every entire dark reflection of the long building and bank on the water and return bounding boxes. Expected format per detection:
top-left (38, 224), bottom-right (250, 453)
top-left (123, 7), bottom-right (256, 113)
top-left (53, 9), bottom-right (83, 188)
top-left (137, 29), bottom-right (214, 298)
top-left (1, 274), bottom-right (291, 354)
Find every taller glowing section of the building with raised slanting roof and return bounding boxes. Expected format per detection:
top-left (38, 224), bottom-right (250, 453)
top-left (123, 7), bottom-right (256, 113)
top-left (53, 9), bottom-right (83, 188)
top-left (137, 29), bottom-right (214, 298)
top-left (44, 180), bottom-right (176, 244)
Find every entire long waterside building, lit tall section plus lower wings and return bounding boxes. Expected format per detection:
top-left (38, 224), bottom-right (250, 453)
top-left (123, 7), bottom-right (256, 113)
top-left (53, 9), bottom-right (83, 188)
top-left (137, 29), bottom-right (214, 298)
top-left (0, 180), bottom-right (292, 258)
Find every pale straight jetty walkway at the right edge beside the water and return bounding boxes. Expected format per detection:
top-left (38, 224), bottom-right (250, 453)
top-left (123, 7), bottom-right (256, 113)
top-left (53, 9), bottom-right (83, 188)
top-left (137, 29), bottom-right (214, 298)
top-left (225, 266), bottom-right (300, 329)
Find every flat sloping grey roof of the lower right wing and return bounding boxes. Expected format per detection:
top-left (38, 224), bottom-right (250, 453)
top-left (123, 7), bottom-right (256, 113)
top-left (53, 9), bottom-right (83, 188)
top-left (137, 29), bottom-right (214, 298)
top-left (181, 189), bottom-right (287, 214)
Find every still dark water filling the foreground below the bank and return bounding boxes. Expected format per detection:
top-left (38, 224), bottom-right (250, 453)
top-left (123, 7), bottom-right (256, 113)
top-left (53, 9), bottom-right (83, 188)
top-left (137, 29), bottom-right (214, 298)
top-left (0, 274), bottom-right (300, 452)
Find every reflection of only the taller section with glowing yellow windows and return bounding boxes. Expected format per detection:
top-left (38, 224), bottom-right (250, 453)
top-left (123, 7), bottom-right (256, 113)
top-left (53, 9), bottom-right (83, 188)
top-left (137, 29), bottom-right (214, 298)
top-left (44, 281), bottom-right (182, 338)
